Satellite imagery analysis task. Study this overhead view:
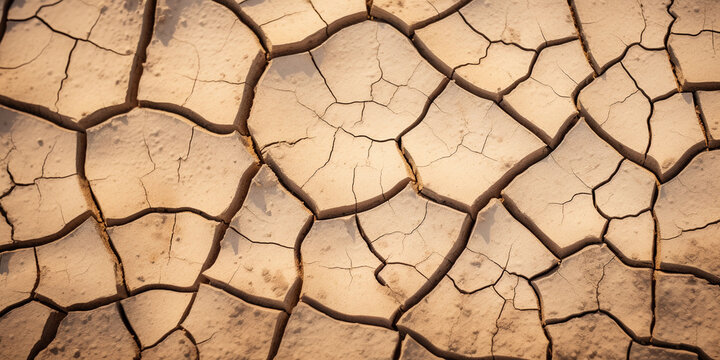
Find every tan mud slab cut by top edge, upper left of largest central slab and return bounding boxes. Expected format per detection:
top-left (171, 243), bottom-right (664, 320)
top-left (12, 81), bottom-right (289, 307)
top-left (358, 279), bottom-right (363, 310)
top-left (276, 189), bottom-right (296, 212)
top-left (138, 0), bottom-right (264, 125)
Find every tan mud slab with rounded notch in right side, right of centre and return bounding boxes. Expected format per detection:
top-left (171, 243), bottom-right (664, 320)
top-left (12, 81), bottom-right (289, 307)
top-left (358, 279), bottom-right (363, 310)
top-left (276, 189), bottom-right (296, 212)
top-left (503, 119), bottom-right (622, 254)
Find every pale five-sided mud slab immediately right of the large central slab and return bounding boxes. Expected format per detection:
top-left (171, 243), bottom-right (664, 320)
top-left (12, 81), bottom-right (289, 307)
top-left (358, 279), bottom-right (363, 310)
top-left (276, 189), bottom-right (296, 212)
top-left (402, 83), bottom-right (544, 212)
